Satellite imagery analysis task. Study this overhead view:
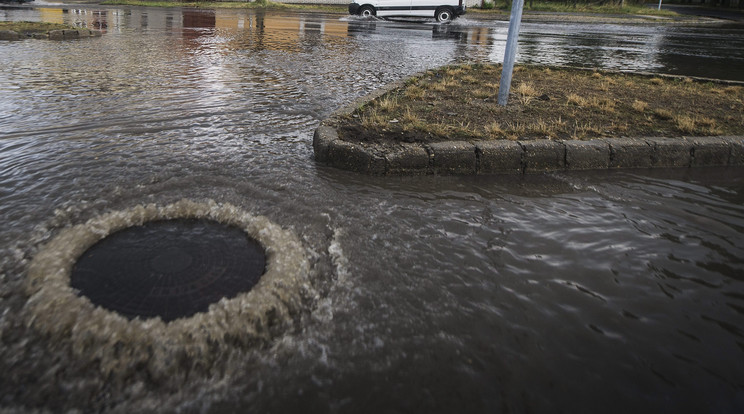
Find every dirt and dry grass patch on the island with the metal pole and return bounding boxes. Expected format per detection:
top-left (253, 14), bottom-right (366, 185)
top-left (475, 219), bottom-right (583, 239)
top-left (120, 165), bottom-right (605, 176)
top-left (328, 64), bottom-right (744, 145)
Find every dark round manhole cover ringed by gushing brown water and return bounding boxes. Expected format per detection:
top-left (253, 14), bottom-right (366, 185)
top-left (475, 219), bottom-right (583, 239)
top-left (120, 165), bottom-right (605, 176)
top-left (70, 219), bottom-right (266, 322)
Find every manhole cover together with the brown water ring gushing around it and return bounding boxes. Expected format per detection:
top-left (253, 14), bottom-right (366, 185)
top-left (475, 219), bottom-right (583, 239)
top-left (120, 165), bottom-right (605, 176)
top-left (24, 200), bottom-right (310, 362)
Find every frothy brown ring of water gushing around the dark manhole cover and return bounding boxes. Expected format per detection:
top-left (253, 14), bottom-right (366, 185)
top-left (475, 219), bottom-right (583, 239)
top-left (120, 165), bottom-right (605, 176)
top-left (25, 200), bottom-right (317, 378)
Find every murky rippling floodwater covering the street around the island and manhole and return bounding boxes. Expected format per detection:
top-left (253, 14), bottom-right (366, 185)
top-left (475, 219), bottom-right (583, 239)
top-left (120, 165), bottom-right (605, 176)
top-left (0, 6), bottom-right (744, 412)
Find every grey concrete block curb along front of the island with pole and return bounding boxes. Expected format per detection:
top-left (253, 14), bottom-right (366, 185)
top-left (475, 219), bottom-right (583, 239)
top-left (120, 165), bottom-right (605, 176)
top-left (313, 125), bottom-right (744, 175)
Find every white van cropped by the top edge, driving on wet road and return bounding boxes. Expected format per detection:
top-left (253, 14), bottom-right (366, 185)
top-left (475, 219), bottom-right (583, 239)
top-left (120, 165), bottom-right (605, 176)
top-left (349, 0), bottom-right (465, 22)
